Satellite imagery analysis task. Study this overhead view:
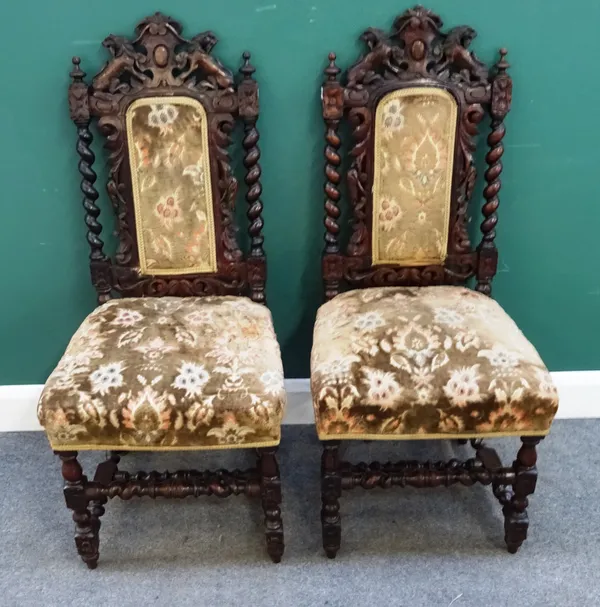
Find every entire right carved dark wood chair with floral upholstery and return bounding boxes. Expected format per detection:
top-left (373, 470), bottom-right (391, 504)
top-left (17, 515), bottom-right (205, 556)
top-left (311, 6), bottom-right (558, 558)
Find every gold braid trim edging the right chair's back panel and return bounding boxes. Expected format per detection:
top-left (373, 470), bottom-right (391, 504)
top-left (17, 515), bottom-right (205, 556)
top-left (371, 87), bottom-right (458, 266)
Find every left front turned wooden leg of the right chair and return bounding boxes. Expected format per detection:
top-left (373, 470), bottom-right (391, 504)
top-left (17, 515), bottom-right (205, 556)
top-left (321, 441), bottom-right (342, 559)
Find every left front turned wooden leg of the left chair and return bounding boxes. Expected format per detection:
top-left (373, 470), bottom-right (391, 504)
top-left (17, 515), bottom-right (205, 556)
top-left (57, 451), bottom-right (99, 569)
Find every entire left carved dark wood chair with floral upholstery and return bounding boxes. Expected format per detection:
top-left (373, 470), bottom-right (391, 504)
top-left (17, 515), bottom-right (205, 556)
top-left (38, 13), bottom-right (285, 568)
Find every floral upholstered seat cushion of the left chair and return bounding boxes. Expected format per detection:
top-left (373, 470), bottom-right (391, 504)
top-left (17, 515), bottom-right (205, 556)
top-left (38, 296), bottom-right (285, 451)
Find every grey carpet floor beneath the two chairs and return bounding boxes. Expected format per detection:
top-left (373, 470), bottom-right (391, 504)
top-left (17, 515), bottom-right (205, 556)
top-left (0, 420), bottom-right (600, 607)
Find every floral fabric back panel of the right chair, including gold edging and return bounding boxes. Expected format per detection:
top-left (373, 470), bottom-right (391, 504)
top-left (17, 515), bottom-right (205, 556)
top-left (372, 88), bottom-right (457, 266)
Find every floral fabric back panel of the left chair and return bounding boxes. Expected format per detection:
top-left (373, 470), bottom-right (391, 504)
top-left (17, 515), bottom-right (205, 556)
top-left (127, 97), bottom-right (217, 274)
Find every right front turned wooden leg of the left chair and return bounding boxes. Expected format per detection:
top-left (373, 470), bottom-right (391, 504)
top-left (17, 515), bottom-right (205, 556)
top-left (258, 447), bottom-right (285, 563)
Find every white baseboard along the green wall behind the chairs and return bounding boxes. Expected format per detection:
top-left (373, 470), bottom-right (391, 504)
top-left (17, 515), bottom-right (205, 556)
top-left (0, 371), bottom-right (600, 432)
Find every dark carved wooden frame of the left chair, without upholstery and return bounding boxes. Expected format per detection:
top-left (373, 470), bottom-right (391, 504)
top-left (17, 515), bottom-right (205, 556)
top-left (57, 13), bottom-right (284, 569)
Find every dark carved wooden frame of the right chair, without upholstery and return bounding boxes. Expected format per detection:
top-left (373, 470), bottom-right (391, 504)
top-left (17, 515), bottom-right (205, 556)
top-left (321, 6), bottom-right (541, 558)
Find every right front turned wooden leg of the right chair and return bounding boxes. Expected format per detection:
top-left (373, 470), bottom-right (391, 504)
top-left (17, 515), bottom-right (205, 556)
top-left (503, 436), bottom-right (542, 554)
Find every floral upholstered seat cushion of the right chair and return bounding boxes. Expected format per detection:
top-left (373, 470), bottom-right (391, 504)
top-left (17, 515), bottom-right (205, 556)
top-left (311, 286), bottom-right (558, 439)
